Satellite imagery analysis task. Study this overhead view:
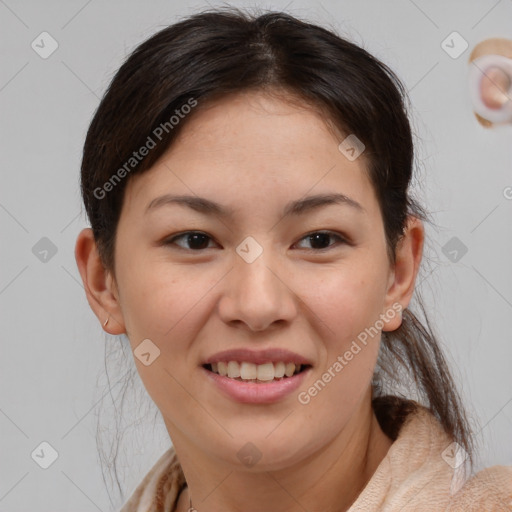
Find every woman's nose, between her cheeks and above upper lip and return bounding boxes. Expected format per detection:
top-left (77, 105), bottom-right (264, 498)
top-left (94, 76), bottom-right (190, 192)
top-left (218, 244), bottom-right (300, 332)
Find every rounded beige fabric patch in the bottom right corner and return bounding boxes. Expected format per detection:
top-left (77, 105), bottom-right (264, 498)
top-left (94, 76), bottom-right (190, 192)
top-left (448, 466), bottom-right (512, 512)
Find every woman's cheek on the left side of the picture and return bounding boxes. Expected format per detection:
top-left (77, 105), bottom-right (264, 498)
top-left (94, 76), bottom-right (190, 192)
top-left (119, 255), bottom-right (210, 413)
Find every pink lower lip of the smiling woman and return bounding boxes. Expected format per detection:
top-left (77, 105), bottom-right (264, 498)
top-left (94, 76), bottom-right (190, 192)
top-left (201, 367), bottom-right (311, 404)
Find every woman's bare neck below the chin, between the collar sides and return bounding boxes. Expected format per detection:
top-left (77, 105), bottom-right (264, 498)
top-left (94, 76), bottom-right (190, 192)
top-left (173, 394), bottom-right (392, 512)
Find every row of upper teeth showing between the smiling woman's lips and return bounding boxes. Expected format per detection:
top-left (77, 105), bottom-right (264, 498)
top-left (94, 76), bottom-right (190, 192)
top-left (203, 361), bottom-right (311, 383)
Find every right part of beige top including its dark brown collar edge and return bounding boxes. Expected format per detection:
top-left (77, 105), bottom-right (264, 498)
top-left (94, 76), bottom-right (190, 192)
top-left (350, 398), bottom-right (512, 512)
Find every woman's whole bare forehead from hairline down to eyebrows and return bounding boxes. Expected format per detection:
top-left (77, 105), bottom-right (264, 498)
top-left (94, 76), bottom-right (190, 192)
top-left (126, 92), bottom-right (376, 220)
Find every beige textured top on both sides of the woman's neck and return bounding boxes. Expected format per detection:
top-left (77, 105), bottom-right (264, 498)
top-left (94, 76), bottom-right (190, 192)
top-left (120, 407), bottom-right (512, 512)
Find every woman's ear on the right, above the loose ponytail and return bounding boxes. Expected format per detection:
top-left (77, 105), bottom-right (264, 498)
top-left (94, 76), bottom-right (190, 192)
top-left (382, 215), bottom-right (425, 331)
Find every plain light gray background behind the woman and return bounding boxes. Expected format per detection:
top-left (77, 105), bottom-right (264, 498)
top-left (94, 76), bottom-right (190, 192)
top-left (0, 0), bottom-right (512, 512)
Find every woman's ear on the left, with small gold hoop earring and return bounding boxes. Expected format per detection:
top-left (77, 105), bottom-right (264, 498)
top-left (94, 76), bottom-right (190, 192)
top-left (75, 228), bottom-right (126, 334)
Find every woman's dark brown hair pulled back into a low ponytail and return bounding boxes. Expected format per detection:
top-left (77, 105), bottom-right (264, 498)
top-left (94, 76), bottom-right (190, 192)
top-left (81, 7), bottom-right (473, 506)
